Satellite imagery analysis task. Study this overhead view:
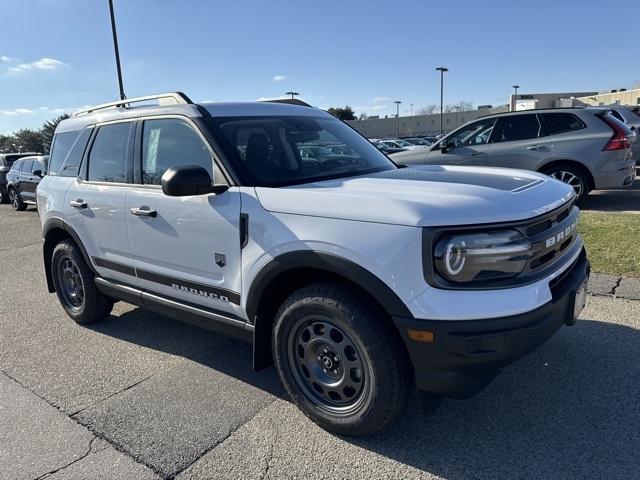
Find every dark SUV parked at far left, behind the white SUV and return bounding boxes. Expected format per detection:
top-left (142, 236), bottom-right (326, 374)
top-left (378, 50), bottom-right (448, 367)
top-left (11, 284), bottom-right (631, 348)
top-left (6, 155), bottom-right (49, 211)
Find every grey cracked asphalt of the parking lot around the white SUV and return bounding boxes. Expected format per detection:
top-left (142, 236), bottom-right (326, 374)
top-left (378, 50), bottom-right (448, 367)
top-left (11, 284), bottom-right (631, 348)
top-left (0, 181), bottom-right (640, 480)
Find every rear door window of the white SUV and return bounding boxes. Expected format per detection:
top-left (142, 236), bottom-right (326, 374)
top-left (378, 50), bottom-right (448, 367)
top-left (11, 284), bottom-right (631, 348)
top-left (87, 123), bottom-right (130, 183)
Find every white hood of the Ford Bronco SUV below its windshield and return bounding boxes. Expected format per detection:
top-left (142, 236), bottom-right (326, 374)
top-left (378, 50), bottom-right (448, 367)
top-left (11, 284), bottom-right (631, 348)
top-left (256, 165), bottom-right (575, 227)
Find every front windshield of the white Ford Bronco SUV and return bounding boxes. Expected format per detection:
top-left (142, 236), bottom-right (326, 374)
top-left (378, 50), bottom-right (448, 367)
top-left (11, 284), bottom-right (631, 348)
top-left (209, 116), bottom-right (396, 186)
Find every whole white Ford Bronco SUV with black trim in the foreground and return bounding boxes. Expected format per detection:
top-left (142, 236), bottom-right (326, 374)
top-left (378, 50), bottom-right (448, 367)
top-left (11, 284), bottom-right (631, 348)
top-left (37, 93), bottom-right (589, 435)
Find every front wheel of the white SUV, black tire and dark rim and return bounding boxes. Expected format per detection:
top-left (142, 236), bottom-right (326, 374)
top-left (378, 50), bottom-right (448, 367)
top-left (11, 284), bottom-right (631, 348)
top-left (272, 282), bottom-right (412, 437)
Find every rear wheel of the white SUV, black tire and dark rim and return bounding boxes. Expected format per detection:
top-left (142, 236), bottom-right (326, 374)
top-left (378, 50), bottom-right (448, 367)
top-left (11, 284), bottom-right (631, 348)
top-left (51, 240), bottom-right (113, 324)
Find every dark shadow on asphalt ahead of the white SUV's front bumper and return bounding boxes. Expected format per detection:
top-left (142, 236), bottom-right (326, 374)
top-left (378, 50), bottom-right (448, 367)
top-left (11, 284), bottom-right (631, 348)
top-left (354, 320), bottom-right (640, 479)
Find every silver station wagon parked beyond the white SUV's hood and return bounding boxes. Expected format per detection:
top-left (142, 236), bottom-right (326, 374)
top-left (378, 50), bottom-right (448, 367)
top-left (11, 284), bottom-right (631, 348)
top-left (390, 108), bottom-right (636, 201)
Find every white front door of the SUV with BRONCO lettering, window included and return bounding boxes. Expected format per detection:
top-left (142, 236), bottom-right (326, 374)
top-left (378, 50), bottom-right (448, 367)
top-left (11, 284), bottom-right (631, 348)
top-left (125, 118), bottom-right (242, 316)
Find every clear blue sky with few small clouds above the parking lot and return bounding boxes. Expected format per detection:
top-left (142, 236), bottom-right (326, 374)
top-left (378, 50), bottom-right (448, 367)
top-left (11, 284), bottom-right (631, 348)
top-left (0, 0), bottom-right (640, 135)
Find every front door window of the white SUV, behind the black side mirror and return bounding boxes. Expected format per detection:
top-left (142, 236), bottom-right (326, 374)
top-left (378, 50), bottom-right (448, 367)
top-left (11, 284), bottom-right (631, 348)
top-left (142, 118), bottom-right (213, 185)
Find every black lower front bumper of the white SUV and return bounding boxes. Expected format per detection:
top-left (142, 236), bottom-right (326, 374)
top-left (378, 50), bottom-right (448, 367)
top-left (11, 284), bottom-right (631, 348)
top-left (393, 250), bottom-right (590, 398)
